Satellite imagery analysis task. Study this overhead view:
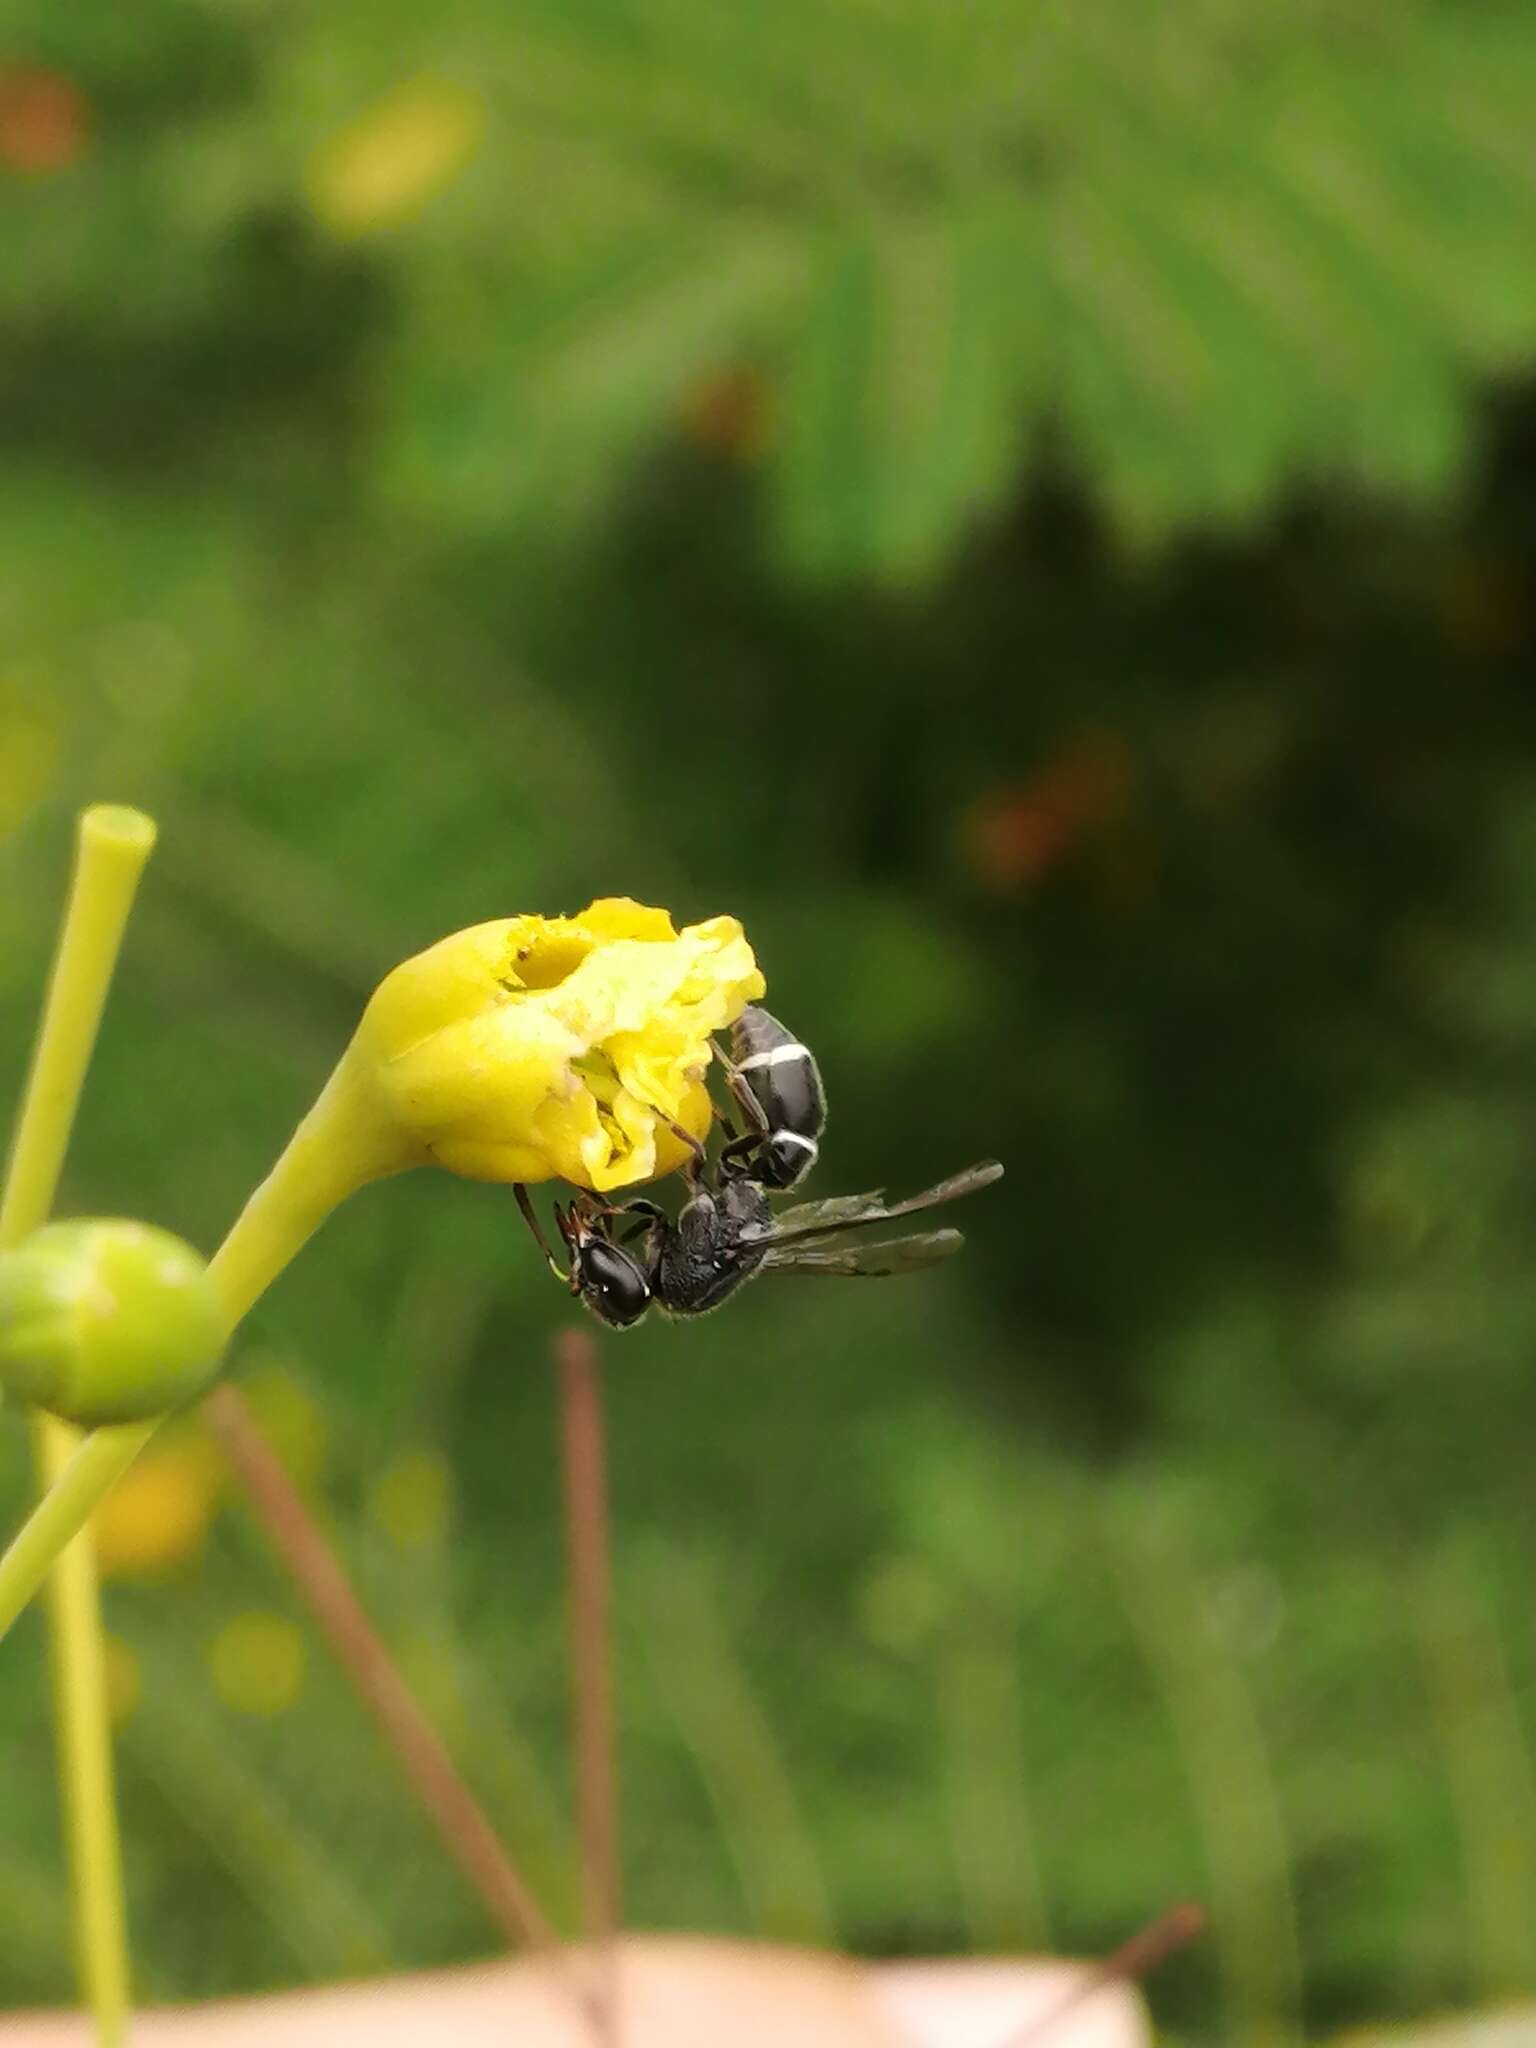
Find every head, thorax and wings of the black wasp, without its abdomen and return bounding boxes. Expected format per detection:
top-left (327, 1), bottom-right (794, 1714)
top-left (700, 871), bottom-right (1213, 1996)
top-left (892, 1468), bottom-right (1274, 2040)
top-left (516, 1159), bottom-right (1004, 1329)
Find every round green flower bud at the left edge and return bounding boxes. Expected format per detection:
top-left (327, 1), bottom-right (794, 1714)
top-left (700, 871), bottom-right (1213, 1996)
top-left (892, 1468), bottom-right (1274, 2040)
top-left (0, 1219), bottom-right (225, 1427)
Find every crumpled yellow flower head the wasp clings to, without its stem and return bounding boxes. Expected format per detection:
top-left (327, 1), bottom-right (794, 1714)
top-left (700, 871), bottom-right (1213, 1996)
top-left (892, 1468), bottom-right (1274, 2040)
top-left (346, 897), bottom-right (764, 1190)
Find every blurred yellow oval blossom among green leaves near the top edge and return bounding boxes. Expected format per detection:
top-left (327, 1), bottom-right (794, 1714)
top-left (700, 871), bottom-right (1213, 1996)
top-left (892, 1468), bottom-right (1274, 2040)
top-left (307, 78), bottom-right (485, 238)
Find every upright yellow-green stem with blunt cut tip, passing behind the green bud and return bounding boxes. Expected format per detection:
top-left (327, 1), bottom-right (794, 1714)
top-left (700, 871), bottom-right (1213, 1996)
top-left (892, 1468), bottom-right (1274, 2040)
top-left (0, 805), bottom-right (156, 2048)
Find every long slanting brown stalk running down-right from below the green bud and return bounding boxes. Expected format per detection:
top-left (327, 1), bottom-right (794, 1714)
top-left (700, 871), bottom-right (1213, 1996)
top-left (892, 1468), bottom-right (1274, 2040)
top-left (203, 1382), bottom-right (577, 1962)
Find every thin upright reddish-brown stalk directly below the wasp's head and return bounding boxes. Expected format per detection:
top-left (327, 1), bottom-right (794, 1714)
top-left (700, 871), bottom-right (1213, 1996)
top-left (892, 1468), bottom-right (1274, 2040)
top-left (555, 1329), bottom-right (623, 2048)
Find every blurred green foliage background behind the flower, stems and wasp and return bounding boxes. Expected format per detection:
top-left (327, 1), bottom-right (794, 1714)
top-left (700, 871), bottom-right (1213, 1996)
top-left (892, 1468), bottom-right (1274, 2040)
top-left (0, 0), bottom-right (1536, 2044)
